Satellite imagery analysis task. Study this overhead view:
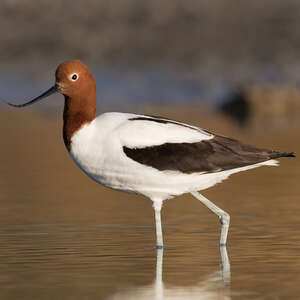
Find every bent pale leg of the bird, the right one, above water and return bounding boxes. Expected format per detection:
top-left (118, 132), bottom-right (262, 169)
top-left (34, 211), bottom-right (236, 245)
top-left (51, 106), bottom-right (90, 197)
top-left (191, 192), bottom-right (230, 246)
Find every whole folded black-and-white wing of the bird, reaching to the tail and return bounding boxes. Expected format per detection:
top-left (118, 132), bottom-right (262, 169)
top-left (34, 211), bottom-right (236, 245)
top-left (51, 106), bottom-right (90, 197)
top-left (119, 116), bottom-right (293, 174)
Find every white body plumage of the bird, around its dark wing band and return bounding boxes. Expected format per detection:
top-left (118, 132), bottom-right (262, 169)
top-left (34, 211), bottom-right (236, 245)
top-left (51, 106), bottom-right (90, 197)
top-left (70, 113), bottom-right (276, 201)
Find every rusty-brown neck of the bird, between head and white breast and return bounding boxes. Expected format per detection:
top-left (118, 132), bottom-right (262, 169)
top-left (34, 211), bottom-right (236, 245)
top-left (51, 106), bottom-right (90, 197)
top-left (63, 92), bottom-right (96, 152)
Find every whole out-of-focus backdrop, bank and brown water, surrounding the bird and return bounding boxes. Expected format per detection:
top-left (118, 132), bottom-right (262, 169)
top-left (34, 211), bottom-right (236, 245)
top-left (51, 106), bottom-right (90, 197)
top-left (0, 0), bottom-right (300, 299)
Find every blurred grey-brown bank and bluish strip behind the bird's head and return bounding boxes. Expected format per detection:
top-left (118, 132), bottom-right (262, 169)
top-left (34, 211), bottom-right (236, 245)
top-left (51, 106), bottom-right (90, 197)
top-left (0, 0), bottom-right (300, 126)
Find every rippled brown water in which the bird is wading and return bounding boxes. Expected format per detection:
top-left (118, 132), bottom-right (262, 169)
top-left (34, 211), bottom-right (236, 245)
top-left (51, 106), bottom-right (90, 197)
top-left (0, 106), bottom-right (300, 299)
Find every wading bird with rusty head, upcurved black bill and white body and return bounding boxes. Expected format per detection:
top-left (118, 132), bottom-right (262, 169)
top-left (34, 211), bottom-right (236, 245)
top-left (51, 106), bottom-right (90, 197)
top-left (5, 60), bottom-right (295, 249)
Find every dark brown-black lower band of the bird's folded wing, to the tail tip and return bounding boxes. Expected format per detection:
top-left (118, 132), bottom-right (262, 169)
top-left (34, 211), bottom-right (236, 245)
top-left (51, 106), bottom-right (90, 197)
top-left (123, 136), bottom-right (294, 173)
